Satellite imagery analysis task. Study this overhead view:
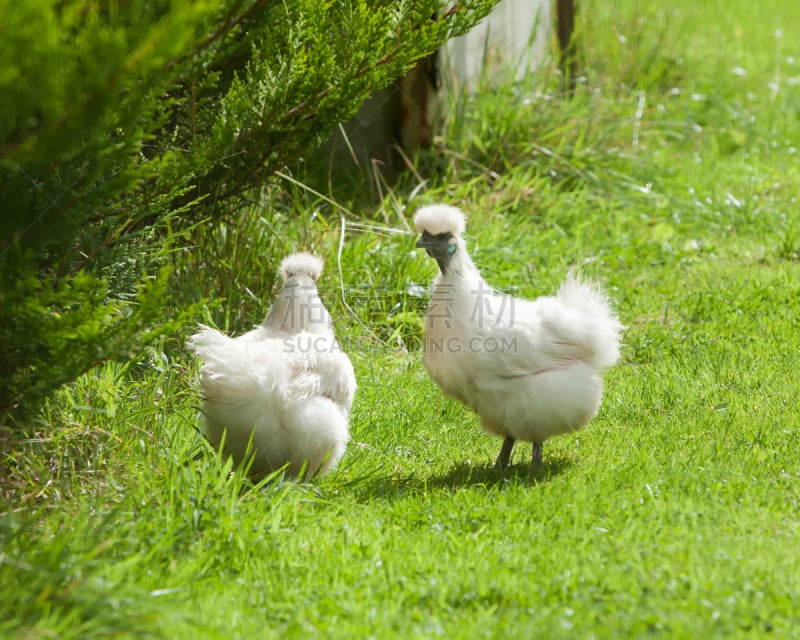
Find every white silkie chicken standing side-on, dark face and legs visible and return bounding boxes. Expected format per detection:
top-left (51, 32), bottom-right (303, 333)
top-left (414, 205), bottom-right (622, 467)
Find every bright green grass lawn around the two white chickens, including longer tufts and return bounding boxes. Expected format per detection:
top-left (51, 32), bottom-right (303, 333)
top-left (0, 0), bottom-right (800, 638)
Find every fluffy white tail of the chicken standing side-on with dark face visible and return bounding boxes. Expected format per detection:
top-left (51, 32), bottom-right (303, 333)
top-left (558, 269), bottom-right (625, 370)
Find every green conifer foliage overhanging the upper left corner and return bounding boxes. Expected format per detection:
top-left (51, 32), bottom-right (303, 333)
top-left (0, 0), bottom-right (496, 425)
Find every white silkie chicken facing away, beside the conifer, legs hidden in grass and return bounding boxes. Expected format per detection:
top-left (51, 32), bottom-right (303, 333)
top-left (190, 253), bottom-right (356, 477)
